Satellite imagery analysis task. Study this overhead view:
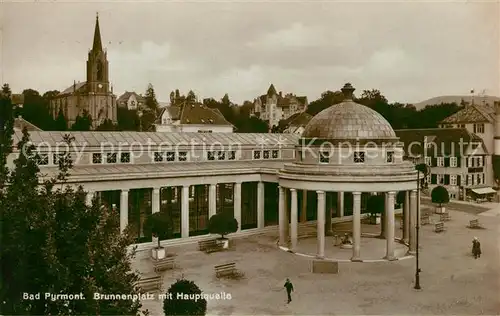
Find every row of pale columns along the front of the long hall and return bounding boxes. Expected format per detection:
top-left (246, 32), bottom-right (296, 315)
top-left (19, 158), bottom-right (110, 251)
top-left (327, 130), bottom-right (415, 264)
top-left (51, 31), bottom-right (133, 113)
top-left (86, 182), bottom-right (264, 238)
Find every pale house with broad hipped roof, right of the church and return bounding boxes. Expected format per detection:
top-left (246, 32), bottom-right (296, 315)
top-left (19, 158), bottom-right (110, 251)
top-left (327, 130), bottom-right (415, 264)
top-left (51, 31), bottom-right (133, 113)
top-left (155, 103), bottom-right (234, 133)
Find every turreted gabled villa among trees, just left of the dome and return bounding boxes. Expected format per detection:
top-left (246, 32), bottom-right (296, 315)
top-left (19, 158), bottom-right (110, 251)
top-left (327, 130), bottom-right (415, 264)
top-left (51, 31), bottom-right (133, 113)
top-left (250, 84), bottom-right (308, 128)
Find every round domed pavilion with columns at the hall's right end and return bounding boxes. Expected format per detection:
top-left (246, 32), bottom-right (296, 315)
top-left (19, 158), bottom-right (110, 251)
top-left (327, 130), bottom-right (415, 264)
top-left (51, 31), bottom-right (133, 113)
top-left (279, 83), bottom-right (418, 261)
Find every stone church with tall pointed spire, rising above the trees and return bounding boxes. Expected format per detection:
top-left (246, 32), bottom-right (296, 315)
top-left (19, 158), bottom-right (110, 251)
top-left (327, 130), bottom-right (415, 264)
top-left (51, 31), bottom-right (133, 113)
top-left (50, 16), bottom-right (117, 128)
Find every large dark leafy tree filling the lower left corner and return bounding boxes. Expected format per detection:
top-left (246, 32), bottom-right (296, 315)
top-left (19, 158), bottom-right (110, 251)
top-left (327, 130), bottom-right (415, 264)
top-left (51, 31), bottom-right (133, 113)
top-left (0, 102), bottom-right (140, 315)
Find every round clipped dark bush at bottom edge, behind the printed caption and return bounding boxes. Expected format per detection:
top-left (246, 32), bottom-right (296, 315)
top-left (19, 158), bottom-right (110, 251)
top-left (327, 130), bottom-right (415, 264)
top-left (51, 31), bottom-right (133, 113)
top-left (163, 279), bottom-right (207, 316)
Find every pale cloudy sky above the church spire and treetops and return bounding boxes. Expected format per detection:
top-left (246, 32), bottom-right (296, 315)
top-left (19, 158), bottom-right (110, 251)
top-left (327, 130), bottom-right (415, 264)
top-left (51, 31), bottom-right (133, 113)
top-left (0, 0), bottom-right (500, 102)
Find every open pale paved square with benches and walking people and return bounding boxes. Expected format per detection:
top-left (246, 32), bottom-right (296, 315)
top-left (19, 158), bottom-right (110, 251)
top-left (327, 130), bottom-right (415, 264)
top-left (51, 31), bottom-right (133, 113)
top-left (136, 210), bottom-right (500, 315)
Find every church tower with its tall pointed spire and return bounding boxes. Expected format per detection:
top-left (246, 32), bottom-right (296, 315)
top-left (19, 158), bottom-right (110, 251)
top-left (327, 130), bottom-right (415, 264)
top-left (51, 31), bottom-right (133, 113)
top-left (87, 15), bottom-right (110, 94)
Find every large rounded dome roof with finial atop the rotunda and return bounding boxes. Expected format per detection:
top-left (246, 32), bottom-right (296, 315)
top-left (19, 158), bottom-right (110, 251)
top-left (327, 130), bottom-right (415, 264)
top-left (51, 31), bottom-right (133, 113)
top-left (302, 83), bottom-right (397, 140)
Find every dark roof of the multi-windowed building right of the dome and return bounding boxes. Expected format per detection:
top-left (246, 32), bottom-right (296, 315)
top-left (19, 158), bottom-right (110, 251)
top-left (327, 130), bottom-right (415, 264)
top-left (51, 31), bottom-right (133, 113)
top-left (395, 128), bottom-right (486, 156)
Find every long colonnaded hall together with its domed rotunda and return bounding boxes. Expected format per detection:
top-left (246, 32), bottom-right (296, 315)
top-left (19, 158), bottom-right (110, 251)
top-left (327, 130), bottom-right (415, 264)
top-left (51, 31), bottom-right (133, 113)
top-left (8, 84), bottom-right (417, 260)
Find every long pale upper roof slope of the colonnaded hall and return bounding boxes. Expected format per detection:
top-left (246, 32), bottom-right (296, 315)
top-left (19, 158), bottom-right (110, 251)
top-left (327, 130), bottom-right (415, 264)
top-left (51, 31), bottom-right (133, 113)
top-left (13, 131), bottom-right (300, 147)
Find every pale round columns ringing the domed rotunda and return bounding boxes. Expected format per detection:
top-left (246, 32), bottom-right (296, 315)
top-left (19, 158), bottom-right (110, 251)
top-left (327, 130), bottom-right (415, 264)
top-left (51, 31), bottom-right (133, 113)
top-left (279, 186), bottom-right (419, 261)
